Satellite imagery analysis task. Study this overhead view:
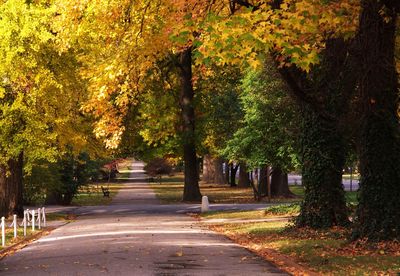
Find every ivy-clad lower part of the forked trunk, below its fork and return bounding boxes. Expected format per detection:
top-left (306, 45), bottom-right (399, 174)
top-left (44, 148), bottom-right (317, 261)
top-left (296, 105), bottom-right (349, 228)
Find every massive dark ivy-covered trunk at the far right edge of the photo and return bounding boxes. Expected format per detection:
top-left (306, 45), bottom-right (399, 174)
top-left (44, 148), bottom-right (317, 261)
top-left (353, 0), bottom-right (400, 240)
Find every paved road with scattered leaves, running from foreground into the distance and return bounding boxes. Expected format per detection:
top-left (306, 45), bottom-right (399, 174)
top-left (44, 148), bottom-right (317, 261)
top-left (0, 162), bottom-right (283, 275)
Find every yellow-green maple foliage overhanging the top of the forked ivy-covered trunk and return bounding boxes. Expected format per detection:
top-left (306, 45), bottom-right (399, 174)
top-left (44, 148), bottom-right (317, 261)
top-left (201, 0), bottom-right (359, 71)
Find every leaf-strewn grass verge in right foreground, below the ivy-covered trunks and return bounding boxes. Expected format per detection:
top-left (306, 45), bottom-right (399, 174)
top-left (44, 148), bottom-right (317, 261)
top-left (209, 221), bottom-right (400, 275)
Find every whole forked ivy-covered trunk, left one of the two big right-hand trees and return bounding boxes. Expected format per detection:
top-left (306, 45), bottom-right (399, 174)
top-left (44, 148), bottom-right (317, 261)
top-left (280, 39), bottom-right (355, 228)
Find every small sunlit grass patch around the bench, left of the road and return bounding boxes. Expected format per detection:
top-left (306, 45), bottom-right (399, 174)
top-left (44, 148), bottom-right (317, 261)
top-left (71, 183), bottom-right (122, 206)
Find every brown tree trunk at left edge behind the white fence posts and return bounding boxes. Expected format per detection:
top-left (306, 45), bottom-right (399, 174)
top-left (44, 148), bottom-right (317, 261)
top-left (0, 153), bottom-right (24, 217)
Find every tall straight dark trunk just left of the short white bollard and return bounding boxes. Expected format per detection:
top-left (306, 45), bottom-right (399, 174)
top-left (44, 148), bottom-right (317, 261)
top-left (179, 47), bottom-right (201, 201)
